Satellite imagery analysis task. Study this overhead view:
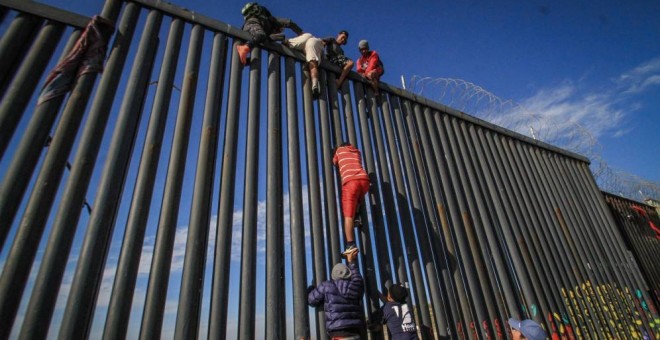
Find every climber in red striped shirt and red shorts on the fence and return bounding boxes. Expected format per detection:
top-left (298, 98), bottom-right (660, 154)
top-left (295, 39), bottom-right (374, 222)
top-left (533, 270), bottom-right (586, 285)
top-left (332, 143), bottom-right (371, 255)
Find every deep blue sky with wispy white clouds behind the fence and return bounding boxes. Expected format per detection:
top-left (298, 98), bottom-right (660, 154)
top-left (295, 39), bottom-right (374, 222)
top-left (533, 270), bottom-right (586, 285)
top-left (0, 0), bottom-right (660, 338)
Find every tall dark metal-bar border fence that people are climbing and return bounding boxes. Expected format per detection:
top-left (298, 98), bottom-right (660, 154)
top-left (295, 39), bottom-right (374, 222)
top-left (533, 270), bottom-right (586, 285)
top-left (0, 0), bottom-right (660, 339)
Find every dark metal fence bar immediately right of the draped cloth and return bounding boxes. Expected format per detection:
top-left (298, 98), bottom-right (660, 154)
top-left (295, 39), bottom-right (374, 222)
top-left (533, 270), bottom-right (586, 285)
top-left (14, 3), bottom-right (139, 338)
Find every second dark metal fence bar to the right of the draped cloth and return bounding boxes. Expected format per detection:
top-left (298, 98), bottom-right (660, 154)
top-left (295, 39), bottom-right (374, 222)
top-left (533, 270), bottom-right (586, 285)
top-left (59, 2), bottom-right (155, 339)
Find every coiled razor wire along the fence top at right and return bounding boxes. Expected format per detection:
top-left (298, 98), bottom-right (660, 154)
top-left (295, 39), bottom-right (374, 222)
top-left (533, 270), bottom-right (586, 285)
top-left (409, 76), bottom-right (660, 201)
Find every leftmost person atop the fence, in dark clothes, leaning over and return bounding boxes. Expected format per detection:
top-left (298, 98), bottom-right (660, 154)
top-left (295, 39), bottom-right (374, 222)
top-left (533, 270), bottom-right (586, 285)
top-left (236, 2), bottom-right (303, 65)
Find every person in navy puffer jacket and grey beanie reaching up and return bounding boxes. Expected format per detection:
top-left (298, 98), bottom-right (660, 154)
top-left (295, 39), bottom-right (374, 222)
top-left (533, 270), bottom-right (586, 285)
top-left (307, 252), bottom-right (364, 340)
